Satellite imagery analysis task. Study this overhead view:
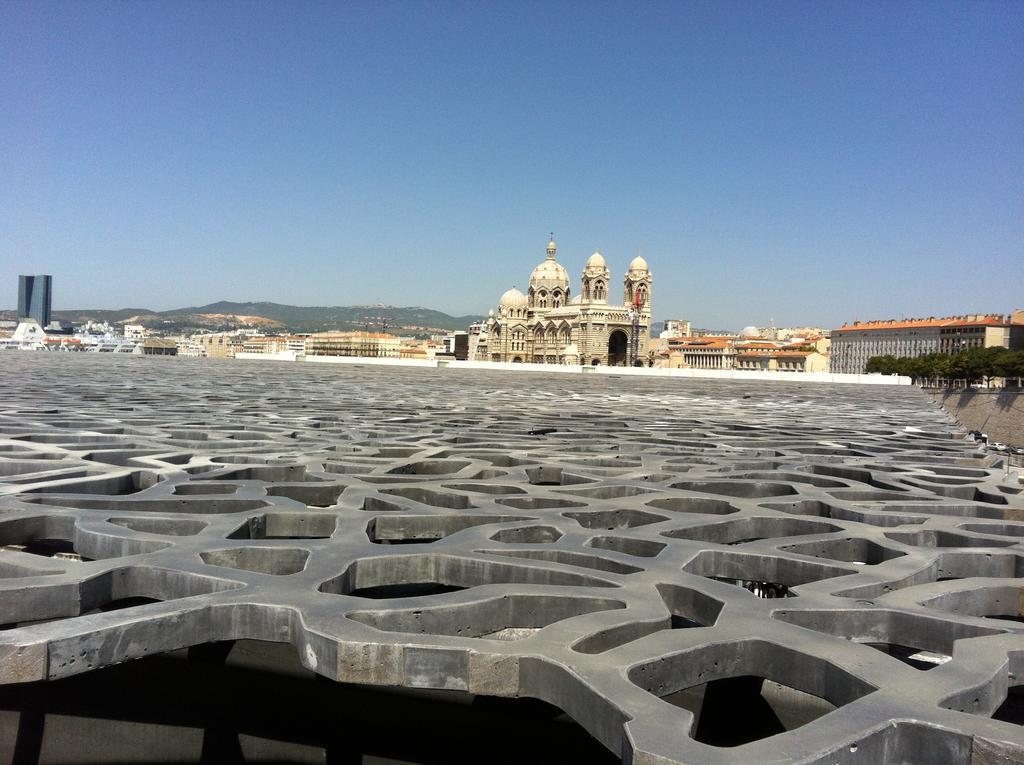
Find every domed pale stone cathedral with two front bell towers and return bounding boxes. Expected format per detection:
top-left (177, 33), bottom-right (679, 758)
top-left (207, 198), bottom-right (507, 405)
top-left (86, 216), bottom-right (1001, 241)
top-left (470, 239), bottom-right (651, 367)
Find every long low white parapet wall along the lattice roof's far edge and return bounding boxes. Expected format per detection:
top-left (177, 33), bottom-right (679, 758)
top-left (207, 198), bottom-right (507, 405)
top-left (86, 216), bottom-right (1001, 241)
top-left (292, 353), bottom-right (911, 385)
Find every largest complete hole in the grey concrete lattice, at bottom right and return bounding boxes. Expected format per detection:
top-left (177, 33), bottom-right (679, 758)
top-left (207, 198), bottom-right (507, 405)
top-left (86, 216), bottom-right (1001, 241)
top-left (628, 640), bottom-right (876, 747)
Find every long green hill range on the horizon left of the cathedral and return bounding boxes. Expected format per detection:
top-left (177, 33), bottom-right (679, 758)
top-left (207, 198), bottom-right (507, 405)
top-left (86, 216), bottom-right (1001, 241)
top-left (0, 300), bottom-right (483, 334)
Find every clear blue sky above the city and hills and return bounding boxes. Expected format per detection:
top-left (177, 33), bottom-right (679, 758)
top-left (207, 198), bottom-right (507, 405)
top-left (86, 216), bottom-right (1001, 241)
top-left (0, 0), bottom-right (1024, 329)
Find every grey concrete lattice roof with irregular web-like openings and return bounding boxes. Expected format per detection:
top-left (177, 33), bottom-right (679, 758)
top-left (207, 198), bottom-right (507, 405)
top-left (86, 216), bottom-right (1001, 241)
top-left (0, 353), bottom-right (1024, 765)
